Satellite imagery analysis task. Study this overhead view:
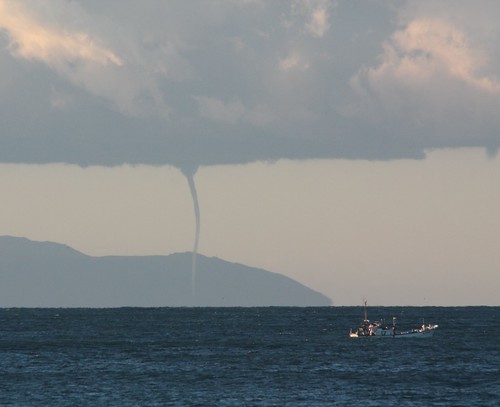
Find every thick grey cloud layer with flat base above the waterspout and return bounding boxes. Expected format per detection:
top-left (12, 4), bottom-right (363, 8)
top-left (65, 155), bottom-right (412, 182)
top-left (0, 0), bottom-right (500, 168)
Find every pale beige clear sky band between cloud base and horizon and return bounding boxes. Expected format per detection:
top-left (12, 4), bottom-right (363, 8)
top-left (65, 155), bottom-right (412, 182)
top-left (0, 150), bottom-right (500, 305)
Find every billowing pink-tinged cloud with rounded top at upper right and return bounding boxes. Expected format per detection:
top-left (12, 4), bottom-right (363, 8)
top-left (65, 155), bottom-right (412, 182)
top-left (344, 18), bottom-right (500, 138)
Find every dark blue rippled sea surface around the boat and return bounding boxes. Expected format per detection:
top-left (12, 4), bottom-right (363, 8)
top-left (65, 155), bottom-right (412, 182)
top-left (0, 307), bottom-right (500, 407)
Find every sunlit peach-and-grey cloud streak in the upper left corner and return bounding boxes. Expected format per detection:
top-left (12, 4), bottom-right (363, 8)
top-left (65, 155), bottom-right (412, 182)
top-left (0, 0), bottom-right (168, 116)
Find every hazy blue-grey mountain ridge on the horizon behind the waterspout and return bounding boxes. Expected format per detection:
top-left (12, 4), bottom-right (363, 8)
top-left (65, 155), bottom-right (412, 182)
top-left (0, 236), bottom-right (331, 307)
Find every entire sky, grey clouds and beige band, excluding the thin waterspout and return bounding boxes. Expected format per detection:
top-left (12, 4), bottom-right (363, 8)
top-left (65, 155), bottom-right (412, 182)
top-left (0, 0), bottom-right (500, 305)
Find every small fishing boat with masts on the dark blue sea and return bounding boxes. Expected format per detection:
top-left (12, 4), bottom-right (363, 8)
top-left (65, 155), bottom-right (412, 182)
top-left (349, 300), bottom-right (439, 338)
